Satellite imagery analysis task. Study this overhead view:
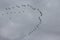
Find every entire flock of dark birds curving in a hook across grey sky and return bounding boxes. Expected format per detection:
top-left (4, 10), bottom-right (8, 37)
top-left (0, 4), bottom-right (43, 39)
